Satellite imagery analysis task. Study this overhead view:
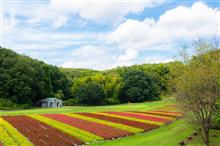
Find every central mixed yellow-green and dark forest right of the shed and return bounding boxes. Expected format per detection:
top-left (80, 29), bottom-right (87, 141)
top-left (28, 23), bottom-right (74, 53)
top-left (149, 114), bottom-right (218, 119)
top-left (60, 56), bottom-right (184, 105)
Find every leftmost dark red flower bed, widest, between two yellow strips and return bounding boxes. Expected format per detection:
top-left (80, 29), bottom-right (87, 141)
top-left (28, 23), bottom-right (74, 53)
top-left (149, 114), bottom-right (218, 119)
top-left (3, 116), bottom-right (83, 146)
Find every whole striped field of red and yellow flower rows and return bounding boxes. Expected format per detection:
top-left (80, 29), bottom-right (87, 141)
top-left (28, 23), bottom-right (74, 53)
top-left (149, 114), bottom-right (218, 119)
top-left (0, 106), bottom-right (182, 146)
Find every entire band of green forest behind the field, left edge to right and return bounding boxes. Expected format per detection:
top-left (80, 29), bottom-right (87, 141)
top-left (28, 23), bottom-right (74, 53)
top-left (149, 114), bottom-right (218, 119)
top-left (0, 49), bottom-right (183, 109)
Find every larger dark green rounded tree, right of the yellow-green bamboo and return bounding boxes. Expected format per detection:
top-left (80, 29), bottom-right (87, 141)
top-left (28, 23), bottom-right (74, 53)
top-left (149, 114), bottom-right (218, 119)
top-left (119, 70), bottom-right (160, 102)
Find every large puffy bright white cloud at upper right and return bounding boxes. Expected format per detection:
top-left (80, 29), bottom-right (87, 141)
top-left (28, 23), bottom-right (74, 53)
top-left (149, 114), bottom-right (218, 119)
top-left (105, 2), bottom-right (220, 51)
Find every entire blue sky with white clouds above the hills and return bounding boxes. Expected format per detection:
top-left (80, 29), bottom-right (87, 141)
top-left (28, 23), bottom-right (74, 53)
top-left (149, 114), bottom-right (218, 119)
top-left (0, 0), bottom-right (220, 70)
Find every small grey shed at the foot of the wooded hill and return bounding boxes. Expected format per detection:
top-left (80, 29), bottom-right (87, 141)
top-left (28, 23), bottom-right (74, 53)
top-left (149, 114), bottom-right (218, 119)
top-left (37, 97), bottom-right (63, 108)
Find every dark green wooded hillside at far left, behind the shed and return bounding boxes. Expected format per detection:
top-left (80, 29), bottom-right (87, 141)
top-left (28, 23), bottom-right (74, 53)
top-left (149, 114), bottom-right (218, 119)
top-left (0, 49), bottom-right (70, 109)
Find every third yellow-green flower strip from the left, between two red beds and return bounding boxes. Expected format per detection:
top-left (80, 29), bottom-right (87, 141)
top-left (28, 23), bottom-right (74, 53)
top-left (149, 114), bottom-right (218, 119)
top-left (65, 114), bottom-right (144, 133)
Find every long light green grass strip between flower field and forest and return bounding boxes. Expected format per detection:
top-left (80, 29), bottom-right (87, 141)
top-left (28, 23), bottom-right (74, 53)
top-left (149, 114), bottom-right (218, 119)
top-left (0, 97), bottom-right (175, 115)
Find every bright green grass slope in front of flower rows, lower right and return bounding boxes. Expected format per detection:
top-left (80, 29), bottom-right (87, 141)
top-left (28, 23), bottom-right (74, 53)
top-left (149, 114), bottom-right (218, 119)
top-left (90, 119), bottom-right (220, 146)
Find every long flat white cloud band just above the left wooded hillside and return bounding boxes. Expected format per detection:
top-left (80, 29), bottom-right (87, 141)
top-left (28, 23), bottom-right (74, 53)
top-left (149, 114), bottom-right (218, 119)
top-left (4, 29), bottom-right (103, 51)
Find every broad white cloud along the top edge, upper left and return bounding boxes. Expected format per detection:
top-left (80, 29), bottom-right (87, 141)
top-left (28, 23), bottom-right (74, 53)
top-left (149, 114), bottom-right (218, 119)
top-left (3, 0), bottom-right (165, 32)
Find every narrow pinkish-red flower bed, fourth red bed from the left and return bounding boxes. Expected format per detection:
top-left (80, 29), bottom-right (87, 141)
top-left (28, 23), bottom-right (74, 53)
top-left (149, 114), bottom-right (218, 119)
top-left (106, 112), bottom-right (170, 122)
